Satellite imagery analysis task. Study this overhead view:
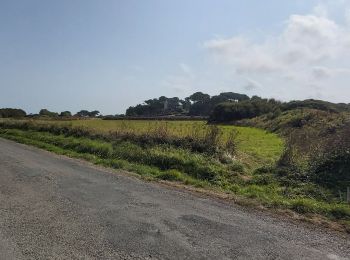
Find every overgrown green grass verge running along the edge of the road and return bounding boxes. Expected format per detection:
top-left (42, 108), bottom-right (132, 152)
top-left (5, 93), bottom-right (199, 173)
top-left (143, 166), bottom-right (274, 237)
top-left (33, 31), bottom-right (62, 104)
top-left (0, 127), bottom-right (350, 232)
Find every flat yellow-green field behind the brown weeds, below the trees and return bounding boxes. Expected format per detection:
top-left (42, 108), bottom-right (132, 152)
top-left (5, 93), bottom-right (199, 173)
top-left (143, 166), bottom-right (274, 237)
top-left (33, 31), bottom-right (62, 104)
top-left (45, 119), bottom-right (284, 168)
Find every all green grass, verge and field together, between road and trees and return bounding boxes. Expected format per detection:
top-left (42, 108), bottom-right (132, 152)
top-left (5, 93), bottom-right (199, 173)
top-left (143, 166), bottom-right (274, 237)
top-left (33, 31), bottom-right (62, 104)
top-left (0, 119), bottom-right (350, 228)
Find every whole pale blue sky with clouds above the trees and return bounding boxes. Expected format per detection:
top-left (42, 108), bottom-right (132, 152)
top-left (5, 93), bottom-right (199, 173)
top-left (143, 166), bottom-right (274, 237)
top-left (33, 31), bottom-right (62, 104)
top-left (0, 0), bottom-right (350, 114)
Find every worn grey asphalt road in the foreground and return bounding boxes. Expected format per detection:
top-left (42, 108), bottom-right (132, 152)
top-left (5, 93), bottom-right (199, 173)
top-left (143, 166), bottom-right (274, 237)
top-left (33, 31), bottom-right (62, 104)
top-left (0, 139), bottom-right (350, 260)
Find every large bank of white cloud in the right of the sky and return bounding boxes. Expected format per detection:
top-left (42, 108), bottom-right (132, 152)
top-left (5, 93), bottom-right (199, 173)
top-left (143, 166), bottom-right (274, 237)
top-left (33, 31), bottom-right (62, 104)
top-left (203, 1), bottom-right (350, 102)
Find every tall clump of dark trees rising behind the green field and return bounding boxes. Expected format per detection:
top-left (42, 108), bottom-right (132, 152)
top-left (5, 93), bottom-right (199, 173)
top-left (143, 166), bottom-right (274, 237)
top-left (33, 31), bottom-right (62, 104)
top-left (125, 92), bottom-right (282, 122)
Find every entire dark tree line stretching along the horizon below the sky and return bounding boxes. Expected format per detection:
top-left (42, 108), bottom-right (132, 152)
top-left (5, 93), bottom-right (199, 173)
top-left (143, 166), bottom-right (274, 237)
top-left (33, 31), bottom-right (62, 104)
top-left (0, 92), bottom-right (350, 122)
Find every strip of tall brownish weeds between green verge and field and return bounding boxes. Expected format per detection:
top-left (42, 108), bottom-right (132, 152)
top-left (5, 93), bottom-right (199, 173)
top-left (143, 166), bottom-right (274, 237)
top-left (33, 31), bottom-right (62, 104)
top-left (0, 121), bottom-right (236, 155)
